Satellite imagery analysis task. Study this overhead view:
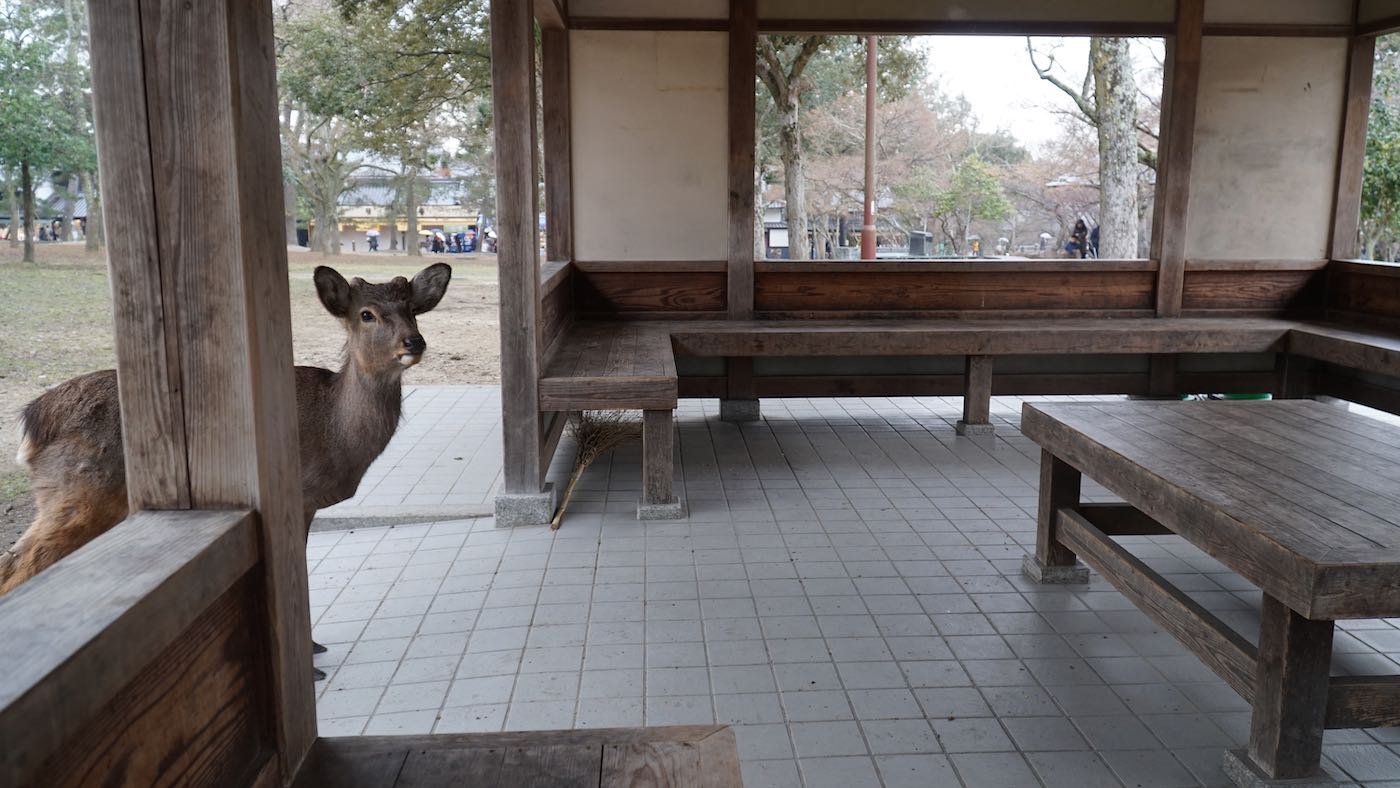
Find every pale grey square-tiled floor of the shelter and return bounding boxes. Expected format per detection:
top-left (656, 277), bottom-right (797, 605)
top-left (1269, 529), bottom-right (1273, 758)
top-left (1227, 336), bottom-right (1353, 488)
top-left (309, 388), bottom-right (1400, 788)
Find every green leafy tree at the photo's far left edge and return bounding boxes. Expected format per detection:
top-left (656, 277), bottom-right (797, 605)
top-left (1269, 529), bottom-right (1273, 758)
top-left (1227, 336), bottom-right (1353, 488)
top-left (0, 3), bottom-right (80, 263)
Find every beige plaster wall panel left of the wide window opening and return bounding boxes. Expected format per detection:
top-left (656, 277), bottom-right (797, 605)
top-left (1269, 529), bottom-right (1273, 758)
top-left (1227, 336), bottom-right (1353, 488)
top-left (568, 30), bottom-right (729, 260)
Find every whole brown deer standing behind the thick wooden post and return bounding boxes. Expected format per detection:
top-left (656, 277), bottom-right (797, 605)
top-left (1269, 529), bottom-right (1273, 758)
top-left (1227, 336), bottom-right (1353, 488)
top-left (0, 263), bottom-right (452, 593)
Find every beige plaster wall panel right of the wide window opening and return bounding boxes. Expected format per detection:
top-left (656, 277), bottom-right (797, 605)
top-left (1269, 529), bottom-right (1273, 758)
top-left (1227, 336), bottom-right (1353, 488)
top-left (1186, 36), bottom-right (1347, 259)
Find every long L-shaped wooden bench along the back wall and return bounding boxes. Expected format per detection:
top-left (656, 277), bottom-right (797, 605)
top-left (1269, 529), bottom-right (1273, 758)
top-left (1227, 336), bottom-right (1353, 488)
top-left (539, 318), bottom-right (1321, 519)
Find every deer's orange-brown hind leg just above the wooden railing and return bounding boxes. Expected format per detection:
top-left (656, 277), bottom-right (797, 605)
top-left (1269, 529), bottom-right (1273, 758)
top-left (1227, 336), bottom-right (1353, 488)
top-left (0, 487), bottom-right (126, 595)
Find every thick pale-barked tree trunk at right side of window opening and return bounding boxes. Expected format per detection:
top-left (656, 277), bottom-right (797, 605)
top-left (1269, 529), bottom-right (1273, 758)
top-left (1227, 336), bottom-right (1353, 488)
top-left (1026, 36), bottom-right (1156, 258)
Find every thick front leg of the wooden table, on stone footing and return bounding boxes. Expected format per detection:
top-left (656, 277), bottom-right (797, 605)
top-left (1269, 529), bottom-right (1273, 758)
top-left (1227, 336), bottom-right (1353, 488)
top-left (1225, 595), bottom-right (1333, 785)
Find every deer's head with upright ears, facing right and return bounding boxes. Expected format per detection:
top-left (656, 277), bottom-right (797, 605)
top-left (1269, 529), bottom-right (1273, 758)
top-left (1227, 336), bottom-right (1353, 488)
top-left (312, 263), bottom-right (452, 377)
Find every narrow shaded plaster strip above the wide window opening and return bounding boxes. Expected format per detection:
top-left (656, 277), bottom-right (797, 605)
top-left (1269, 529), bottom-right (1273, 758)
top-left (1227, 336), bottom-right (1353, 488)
top-left (759, 0), bottom-right (1176, 22)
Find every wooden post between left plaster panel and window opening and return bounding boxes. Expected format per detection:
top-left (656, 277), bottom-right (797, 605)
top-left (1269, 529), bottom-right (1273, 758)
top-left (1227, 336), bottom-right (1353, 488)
top-left (728, 0), bottom-right (759, 319)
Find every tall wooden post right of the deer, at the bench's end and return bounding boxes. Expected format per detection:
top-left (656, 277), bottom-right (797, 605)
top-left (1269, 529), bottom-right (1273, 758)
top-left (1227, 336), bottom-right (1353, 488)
top-left (491, 0), bottom-right (542, 494)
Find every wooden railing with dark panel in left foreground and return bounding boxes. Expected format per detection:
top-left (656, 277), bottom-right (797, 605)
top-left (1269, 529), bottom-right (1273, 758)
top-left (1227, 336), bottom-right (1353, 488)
top-left (0, 509), bottom-right (270, 787)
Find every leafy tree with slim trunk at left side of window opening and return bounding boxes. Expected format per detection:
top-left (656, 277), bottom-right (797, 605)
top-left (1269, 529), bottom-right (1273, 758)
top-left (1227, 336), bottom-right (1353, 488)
top-left (756, 35), bottom-right (925, 260)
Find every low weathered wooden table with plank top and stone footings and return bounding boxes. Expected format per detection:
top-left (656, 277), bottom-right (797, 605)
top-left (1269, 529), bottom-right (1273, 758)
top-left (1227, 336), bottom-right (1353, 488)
top-left (1022, 400), bottom-right (1400, 785)
